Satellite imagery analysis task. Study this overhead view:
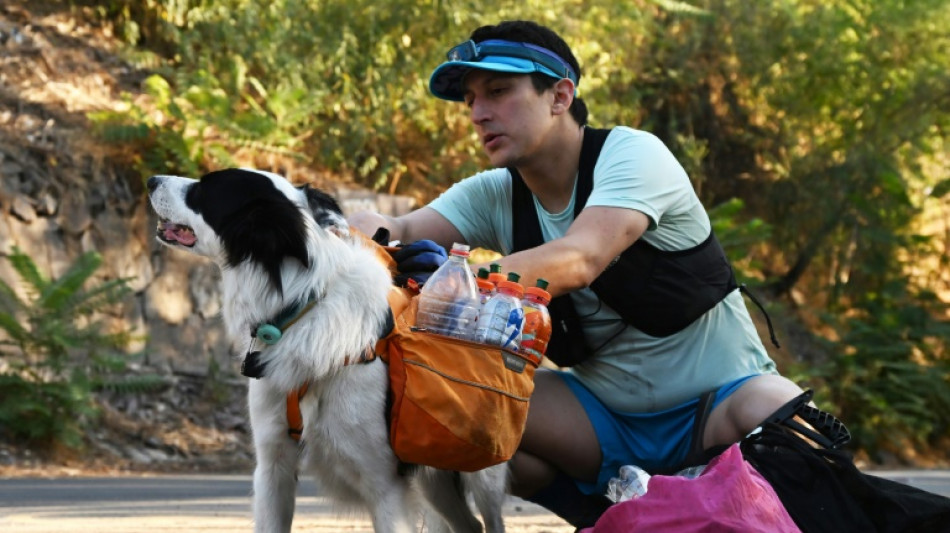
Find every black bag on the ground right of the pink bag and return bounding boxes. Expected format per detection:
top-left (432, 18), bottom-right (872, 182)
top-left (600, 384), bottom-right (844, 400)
top-left (740, 391), bottom-right (950, 533)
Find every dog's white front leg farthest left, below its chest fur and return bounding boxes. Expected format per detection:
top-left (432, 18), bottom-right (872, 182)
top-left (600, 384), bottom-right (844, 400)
top-left (248, 379), bottom-right (299, 533)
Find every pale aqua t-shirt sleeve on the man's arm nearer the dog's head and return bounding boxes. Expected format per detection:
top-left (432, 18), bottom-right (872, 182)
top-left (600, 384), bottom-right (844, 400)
top-left (429, 168), bottom-right (511, 254)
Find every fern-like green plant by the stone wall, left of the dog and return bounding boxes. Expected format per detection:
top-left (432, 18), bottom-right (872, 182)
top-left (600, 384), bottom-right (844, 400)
top-left (0, 249), bottom-right (155, 447)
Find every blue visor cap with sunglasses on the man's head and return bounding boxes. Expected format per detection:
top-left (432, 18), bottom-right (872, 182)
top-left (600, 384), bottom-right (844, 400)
top-left (429, 39), bottom-right (577, 102)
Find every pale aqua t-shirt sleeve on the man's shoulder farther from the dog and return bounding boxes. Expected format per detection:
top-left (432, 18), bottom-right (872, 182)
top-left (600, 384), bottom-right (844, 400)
top-left (587, 126), bottom-right (695, 230)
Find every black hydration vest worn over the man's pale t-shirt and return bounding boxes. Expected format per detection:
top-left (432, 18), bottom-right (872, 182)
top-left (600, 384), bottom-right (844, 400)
top-left (508, 127), bottom-right (739, 366)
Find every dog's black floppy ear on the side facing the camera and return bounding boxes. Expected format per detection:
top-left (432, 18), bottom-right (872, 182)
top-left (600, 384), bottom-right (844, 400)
top-left (221, 196), bottom-right (310, 292)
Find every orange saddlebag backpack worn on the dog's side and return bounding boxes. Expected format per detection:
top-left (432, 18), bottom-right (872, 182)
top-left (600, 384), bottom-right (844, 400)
top-left (376, 278), bottom-right (540, 472)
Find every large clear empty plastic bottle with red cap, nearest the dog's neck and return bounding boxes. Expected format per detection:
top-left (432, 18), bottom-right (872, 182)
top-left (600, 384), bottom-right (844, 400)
top-left (416, 243), bottom-right (480, 340)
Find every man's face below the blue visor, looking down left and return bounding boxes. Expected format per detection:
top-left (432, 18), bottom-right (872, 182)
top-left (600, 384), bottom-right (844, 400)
top-left (463, 69), bottom-right (554, 167)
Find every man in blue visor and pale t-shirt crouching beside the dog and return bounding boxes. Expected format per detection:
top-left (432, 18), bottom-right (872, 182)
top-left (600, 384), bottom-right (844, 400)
top-left (350, 21), bottom-right (802, 527)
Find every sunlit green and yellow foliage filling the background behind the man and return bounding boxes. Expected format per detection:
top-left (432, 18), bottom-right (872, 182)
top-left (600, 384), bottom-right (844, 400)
top-left (87, 0), bottom-right (950, 458)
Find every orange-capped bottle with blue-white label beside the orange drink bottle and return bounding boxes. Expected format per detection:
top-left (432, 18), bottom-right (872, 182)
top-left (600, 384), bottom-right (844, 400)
top-left (475, 273), bottom-right (524, 351)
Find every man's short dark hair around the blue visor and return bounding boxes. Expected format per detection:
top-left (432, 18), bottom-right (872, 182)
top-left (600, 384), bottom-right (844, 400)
top-left (470, 20), bottom-right (587, 126)
